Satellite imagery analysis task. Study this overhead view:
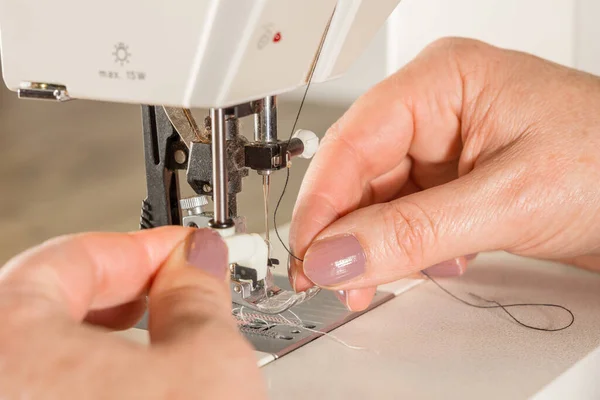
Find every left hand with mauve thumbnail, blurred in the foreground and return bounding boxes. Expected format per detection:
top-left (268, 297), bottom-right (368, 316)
top-left (0, 228), bottom-right (266, 399)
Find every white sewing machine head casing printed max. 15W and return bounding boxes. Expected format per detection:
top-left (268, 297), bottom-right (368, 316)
top-left (0, 0), bottom-right (399, 108)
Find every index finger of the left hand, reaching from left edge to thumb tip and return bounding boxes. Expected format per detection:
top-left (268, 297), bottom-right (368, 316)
top-left (0, 227), bottom-right (191, 321)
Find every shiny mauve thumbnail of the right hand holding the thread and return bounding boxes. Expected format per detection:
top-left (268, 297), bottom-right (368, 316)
top-left (304, 235), bottom-right (366, 286)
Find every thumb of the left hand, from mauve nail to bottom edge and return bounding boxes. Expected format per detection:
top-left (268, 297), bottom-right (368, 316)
top-left (148, 229), bottom-right (265, 399)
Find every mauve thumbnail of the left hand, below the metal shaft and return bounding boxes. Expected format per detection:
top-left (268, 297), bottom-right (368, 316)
top-left (186, 228), bottom-right (228, 279)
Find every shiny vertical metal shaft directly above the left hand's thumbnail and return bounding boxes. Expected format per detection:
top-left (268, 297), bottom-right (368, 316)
top-left (210, 108), bottom-right (231, 227)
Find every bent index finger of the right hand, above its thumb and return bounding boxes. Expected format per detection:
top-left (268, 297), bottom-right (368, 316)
top-left (290, 38), bottom-right (478, 288)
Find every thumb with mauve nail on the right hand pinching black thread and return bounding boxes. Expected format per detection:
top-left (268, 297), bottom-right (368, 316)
top-left (303, 168), bottom-right (512, 290)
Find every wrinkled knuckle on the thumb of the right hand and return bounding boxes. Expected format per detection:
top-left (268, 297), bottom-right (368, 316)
top-left (383, 201), bottom-right (437, 268)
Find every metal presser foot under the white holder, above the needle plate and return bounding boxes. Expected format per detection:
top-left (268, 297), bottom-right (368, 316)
top-left (231, 271), bottom-right (320, 314)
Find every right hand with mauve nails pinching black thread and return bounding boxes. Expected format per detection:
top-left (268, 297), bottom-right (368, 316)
top-left (289, 39), bottom-right (600, 310)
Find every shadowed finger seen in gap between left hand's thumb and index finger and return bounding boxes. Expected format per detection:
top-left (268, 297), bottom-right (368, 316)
top-left (85, 298), bottom-right (146, 330)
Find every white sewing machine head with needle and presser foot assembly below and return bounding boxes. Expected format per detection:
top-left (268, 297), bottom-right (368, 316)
top-left (0, 0), bottom-right (399, 314)
